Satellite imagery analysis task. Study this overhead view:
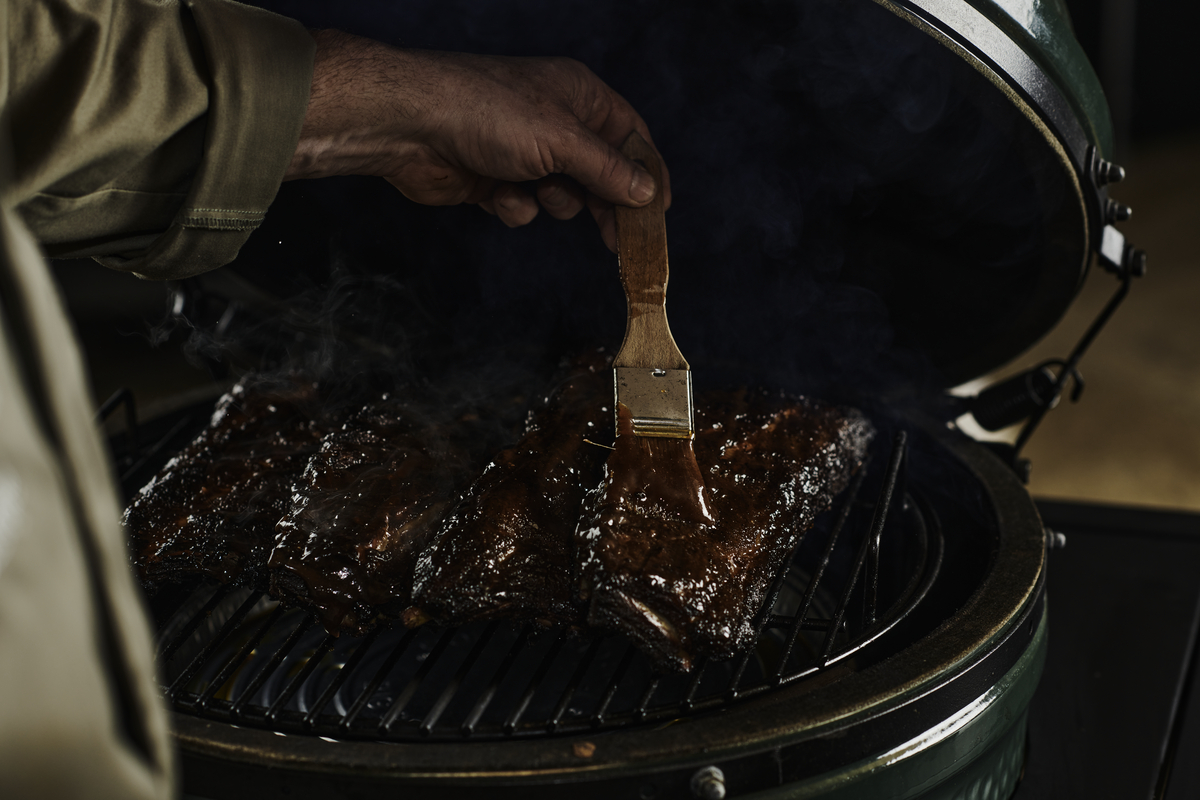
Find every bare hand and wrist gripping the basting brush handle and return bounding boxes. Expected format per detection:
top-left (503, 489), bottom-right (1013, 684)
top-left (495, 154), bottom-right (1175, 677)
top-left (284, 31), bottom-right (671, 251)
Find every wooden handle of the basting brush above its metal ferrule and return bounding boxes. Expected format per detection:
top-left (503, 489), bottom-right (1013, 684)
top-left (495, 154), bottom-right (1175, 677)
top-left (613, 131), bottom-right (688, 369)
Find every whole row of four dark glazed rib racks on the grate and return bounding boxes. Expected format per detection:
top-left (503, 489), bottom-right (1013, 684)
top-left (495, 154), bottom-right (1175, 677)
top-left (126, 367), bottom-right (871, 670)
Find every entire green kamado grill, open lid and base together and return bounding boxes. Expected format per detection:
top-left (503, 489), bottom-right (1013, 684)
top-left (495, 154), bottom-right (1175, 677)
top-left (104, 0), bottom-right (1145, 799)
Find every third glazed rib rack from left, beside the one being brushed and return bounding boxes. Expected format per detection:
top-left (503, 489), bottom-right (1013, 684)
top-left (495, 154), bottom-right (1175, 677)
top-left (415, 353), bottom-right (612, 625)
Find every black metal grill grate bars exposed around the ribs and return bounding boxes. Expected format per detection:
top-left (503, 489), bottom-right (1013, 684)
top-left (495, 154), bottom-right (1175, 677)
top-left (147, 433), bottom-right (942, 741)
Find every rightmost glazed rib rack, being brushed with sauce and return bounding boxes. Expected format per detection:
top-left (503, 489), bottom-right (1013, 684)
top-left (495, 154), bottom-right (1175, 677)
top-left (576, 392), bottom-right (871, 670)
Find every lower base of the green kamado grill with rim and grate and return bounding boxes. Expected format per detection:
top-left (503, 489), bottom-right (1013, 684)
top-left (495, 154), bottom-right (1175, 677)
top-left (114, 414), bottom-right (1045, 798)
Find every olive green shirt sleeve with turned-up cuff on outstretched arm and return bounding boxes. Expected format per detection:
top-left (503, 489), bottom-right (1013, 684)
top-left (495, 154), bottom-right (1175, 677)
top-left (2, 0), bottom-right (314, 278)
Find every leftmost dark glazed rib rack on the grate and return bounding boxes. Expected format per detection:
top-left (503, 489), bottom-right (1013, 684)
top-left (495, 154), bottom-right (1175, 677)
top-left (125, 377), bottom-right (323, 585)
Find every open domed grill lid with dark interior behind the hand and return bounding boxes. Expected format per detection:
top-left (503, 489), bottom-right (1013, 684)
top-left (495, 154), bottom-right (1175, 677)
top-left (220, 0), bottom-right (1129, 397)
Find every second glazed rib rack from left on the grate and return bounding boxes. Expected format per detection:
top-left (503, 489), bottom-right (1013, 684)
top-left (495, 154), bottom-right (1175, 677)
top-left (269, 401), bottom-right (482, 633)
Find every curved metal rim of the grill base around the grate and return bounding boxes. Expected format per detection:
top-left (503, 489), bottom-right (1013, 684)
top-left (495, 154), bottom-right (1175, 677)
top-left (173, 420), bottom-right (1045, 790)
